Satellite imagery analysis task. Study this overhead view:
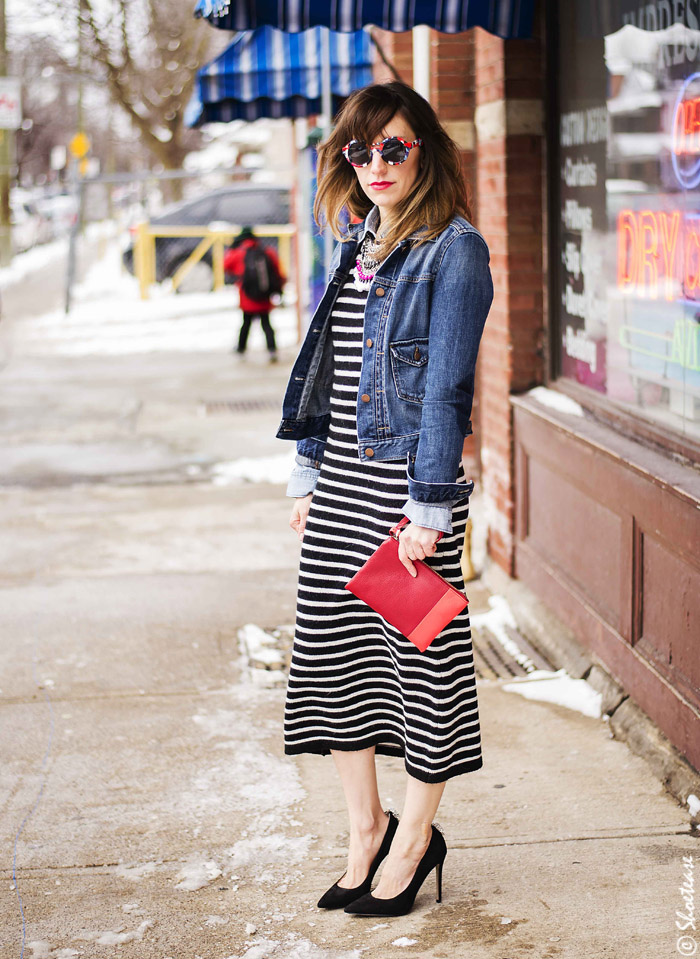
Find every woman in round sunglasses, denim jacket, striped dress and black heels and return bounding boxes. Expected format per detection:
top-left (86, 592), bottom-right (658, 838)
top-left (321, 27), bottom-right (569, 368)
top-left (277, 82), bottom-right (493, 915)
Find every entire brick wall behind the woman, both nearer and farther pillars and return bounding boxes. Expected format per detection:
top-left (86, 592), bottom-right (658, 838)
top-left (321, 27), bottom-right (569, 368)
top-left (376, 29), bottom-right (544, 575)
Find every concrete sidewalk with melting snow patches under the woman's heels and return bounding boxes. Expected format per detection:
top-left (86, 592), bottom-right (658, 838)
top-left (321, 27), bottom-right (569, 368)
top-left (0, 342), bottom-right (700, 959)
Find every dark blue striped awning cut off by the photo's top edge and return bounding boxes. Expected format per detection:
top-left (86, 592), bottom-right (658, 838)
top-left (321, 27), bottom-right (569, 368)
top-left (195, 0), bottom-right (534, 38)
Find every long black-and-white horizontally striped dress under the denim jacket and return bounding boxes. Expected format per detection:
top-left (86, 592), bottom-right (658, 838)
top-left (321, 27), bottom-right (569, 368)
top-left (284, 266), bottom-right (482, 782)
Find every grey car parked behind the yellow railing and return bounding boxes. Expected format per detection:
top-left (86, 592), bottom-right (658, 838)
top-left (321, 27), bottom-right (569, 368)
top-left (123, 183), bottom-right (291, 292)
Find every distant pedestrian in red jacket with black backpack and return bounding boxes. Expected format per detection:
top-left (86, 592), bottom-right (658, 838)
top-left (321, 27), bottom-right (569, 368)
top-left (224, 226), bottom-right (286, 363)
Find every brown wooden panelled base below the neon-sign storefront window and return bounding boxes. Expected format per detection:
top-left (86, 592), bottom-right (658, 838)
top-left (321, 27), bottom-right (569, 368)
top-left (512, 394), bottom-right (700, 769)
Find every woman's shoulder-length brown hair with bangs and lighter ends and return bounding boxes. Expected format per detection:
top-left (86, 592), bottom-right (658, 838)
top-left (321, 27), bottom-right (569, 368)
top-left (314, 80), bottom-right (471, 257)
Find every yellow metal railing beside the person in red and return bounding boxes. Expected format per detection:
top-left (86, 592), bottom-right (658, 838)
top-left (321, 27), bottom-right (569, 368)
top-left (134, 223), bottom-right (296, 300)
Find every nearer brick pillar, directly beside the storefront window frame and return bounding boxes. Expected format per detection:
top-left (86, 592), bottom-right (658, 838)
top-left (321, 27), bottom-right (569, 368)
top-left (472, 29), bottom-right (544, 575)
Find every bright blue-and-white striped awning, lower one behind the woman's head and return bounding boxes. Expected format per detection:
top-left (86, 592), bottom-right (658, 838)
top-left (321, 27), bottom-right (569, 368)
top-left (185, 27), bottom-right (373, 126)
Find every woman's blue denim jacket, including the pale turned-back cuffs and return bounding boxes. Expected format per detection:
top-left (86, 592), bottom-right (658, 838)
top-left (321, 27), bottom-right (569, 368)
top-left (277, 206), bottom-right (493, 533)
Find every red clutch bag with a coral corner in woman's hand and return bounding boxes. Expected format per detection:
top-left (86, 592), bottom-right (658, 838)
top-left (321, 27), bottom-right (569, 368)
top-left (345, 517), bottom-right (469, 652)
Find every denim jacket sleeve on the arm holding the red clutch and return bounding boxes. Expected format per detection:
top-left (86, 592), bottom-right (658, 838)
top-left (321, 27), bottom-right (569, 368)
top-left (407, 233), bottom-right (493, 512)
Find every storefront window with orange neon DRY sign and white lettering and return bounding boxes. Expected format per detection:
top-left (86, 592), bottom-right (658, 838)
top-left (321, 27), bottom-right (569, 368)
top-left (554, 0), bottom-right (700, 438)
